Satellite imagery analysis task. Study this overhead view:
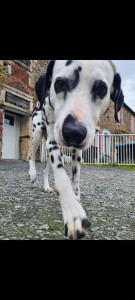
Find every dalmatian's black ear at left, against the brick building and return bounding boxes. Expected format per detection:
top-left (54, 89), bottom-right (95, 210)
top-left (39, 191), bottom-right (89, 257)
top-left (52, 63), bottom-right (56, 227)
top-left (35, 60), bottom-right (55, 109)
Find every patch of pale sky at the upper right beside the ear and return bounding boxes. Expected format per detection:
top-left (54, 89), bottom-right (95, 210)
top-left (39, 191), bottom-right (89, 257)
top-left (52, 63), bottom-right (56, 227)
top-left (113, 60), bottom-right (135, 112)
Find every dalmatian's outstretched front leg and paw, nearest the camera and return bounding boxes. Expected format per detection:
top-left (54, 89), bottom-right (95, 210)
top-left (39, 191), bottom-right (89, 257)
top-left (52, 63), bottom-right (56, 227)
top-left (47, 138), bottom-right (90, 239)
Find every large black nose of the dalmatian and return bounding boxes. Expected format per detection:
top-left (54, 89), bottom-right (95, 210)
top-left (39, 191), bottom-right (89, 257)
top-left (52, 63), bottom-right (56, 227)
top-left (62, 115), bottom-right (87, 147)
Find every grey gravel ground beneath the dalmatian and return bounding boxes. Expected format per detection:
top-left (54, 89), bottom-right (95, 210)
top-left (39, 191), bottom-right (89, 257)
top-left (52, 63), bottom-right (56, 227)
top-left (0, 161), bottom-right (135, 240)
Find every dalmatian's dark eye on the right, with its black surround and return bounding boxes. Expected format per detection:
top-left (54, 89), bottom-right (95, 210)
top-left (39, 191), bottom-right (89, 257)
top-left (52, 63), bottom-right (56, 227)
top-left (92, 80), bottom-right (107, 99)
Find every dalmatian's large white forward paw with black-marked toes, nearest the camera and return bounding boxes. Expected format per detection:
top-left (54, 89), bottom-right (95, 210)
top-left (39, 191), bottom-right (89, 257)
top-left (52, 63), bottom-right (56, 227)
top-left (63, 196), bottom-right (90, 239)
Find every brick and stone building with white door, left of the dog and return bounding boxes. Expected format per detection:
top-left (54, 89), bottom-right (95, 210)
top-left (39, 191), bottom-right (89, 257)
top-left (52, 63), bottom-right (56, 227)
top-left (0, 60), bottom-right (49, 160)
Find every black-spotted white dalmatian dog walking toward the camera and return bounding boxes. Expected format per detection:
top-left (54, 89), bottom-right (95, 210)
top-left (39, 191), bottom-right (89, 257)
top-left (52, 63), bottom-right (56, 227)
top-left (29, 60), bottom-right (124, 239)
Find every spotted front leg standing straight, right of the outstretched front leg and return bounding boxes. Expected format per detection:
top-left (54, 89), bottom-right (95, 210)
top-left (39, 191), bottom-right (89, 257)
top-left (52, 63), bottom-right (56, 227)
top-left (72, 149), bottom-right (82, 201)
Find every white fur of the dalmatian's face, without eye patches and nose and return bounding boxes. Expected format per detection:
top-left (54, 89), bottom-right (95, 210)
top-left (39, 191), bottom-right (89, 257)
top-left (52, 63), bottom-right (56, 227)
top-left (50, 60), bottom-right (114, 150)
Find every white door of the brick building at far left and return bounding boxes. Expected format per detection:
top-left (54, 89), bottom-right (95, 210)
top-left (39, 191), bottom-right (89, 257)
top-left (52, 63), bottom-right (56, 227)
top-left (2, 112), bottom-right (20, 159)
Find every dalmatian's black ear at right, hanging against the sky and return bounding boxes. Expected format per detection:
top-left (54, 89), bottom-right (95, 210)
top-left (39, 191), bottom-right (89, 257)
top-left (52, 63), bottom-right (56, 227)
top-left (111, 73), bottom-right (124, 123)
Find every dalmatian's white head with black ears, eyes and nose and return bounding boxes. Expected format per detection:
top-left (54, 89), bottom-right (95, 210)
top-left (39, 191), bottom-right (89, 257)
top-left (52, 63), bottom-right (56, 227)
top-left (36, 60), bottom-right (124, 150)
